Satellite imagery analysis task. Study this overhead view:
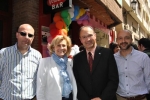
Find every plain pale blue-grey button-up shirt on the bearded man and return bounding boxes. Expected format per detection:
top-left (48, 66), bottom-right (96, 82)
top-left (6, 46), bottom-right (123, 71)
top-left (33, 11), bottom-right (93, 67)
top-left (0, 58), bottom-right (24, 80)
top-left (114, 48), bottom-right (150, 97)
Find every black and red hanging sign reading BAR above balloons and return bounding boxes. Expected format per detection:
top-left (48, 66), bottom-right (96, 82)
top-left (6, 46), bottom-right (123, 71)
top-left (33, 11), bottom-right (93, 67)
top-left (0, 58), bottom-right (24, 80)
top-left (47, 0), bottom-right (72, 11)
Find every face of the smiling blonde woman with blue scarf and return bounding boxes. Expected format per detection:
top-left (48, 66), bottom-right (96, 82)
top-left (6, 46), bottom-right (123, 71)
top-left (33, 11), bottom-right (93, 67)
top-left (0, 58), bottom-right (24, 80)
top-left (54, 40), bottom-right (67, 57)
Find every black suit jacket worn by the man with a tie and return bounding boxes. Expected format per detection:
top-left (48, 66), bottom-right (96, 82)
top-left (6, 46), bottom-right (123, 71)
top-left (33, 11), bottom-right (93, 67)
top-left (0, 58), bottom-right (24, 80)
top-left (73, 46), bottom-right (119, 100)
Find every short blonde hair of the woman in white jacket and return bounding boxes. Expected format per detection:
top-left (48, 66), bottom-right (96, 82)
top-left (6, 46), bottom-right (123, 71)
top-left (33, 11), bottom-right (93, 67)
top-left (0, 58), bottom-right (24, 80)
top-left (49, 35), bottom-right (72, 56)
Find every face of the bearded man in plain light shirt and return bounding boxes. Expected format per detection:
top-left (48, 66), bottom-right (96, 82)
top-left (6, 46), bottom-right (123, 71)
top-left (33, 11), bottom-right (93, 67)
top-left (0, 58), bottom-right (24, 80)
top-left (117, 30), bottom-right (132, 50)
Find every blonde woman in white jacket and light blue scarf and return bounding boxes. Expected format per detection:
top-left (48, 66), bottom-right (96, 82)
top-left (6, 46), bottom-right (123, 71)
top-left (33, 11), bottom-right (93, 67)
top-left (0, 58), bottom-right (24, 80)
top-left (36, 35), bottom-right (77, 100)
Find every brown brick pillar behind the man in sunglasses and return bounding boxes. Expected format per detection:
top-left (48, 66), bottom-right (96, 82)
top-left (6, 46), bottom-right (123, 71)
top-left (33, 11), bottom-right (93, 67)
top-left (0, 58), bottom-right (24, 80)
top-left (12, 0), bottom-right (40, 50)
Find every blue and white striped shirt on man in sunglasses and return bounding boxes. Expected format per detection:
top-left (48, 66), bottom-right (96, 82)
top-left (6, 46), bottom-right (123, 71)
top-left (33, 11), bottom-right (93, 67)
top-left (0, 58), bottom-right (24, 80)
top-left (0, 44), bottom-right (42, 100)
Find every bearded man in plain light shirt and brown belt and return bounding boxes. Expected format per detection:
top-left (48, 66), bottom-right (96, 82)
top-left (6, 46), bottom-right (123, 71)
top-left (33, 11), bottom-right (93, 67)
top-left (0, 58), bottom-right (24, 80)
top-left (114, 30), bottom-right (150, 100)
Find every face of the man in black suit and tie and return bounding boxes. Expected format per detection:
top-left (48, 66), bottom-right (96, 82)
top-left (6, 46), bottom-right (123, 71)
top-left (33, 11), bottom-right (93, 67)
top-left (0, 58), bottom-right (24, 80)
top-left (80, 27), bottom-right (96, 51)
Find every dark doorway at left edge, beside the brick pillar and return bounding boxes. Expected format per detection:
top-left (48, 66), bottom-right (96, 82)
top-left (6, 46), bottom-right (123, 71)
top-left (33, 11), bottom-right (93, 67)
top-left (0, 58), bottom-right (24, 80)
top-left (0, 0), bottom-right (12, 49)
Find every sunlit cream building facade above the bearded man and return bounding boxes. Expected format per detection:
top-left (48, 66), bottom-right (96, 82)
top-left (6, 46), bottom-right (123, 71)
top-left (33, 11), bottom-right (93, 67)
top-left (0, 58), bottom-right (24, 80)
top-left (115, 0), bottom-right (150, 44)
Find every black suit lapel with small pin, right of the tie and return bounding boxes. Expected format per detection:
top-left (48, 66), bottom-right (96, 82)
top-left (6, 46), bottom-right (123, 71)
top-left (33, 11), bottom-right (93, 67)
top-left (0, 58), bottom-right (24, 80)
top-left (92, 46), bottom-right (101, 73)
